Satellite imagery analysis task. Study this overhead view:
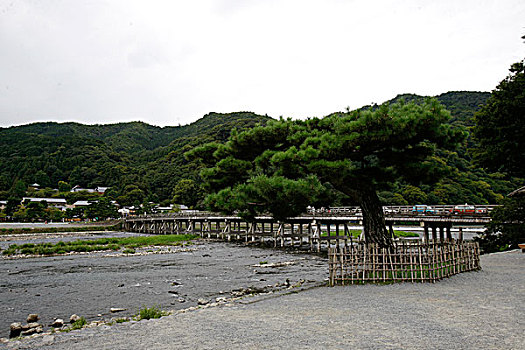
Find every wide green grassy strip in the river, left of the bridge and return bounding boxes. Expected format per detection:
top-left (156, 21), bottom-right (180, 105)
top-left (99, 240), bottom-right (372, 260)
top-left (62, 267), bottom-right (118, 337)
top-left (2, 235), bottom-right (198, 256)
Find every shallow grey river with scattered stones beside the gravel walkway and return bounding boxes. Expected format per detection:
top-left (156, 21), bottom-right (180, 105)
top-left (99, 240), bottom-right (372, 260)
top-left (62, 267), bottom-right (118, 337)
top-left (0, 233), bottom-right (328, 337)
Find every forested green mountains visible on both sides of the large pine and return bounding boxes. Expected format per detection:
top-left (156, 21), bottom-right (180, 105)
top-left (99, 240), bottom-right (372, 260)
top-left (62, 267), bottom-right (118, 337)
top-left (0, 92), bottom-right (520, 208)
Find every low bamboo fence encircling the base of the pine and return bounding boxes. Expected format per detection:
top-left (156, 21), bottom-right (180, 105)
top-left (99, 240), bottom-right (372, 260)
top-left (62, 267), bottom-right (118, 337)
top-left (328, 241), bottom-right (481, 286)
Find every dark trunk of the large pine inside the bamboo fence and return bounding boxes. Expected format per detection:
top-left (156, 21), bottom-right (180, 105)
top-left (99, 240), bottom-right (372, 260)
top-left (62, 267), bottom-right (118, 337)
top-left (359, 188), bottom-right (394, 248)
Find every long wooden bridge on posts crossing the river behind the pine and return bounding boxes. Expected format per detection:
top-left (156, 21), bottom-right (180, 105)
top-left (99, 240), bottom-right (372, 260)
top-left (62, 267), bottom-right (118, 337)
top-left (123, 211), bottom-right (490, 252)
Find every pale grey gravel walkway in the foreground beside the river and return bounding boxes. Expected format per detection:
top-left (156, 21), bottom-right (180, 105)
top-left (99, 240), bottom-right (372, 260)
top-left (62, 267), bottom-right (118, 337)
top-left (4, 251), bottom-right (525, 349)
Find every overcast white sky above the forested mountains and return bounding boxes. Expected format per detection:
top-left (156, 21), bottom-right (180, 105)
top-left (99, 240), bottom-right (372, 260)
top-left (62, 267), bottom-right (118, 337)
top-left (0, 0), bottom-right (525, 126)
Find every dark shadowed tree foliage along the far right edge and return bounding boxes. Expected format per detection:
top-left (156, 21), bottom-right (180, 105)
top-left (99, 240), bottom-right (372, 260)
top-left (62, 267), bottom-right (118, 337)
top-left (474, 61), bottom-right (525, 253)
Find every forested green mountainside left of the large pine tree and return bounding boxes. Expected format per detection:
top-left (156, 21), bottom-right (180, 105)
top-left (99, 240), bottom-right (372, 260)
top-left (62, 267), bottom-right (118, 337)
top-left (0, 112), bottom-right (269, 202)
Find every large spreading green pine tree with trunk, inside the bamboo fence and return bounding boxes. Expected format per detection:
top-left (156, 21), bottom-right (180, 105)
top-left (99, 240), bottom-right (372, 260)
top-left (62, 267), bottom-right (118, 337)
top-left (188, 99), bottom-right (465, 247)
